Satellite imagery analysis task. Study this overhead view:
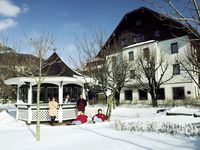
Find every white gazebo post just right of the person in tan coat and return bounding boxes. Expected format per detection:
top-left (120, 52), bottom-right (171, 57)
top-left (58, 81), bottom-right (63, 123)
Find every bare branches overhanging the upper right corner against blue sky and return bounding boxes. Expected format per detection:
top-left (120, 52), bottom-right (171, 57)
top-left (142, 0), bottom-right (200, 40)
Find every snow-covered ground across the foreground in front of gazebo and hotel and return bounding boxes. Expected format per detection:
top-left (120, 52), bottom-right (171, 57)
top-left (0, 105), bottom-right (200, 150)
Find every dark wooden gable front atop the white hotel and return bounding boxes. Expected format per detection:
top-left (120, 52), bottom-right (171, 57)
top-left (104, 7), bottom-right (188, 51)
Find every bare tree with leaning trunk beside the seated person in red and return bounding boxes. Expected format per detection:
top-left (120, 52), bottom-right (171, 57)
top-left (106, 49), bottom-right (130, 118)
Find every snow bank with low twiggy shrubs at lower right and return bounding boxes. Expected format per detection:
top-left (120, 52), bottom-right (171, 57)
top-left (112, 107), bottom-right (200, 136)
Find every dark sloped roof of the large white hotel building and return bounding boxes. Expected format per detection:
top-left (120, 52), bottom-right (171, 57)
top-left (97, 7), bottom-right (196, 57)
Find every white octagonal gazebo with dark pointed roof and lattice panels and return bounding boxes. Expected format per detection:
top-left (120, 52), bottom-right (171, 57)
top-left (4, 52), bottom-right (92, 124)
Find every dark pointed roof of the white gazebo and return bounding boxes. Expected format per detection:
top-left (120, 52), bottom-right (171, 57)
top-left (42, 52), bottom-right (81, 77)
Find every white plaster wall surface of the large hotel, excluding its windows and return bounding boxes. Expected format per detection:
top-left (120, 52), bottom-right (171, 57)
top-left (120, 36), bottom-right (198, 100)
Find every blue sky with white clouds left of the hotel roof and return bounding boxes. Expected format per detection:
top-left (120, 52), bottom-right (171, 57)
top-left (0, 0), bottom-right (155, 66)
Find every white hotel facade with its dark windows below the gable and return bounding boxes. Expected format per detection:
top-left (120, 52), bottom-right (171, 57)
top-left (116, 36), bottom-right (199, 101)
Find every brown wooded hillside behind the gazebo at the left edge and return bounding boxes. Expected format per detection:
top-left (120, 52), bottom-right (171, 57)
top-left (0, 51), bottom-right (38, 103)
